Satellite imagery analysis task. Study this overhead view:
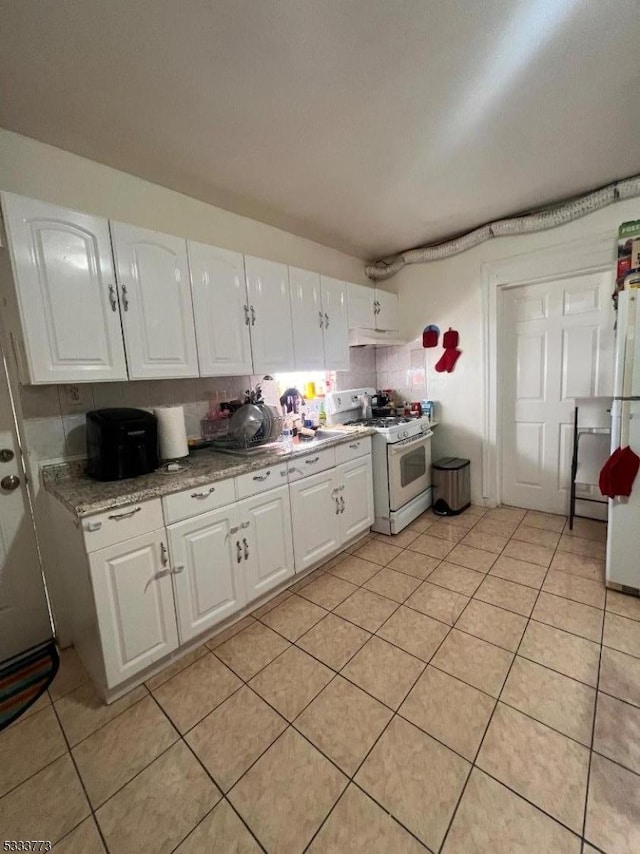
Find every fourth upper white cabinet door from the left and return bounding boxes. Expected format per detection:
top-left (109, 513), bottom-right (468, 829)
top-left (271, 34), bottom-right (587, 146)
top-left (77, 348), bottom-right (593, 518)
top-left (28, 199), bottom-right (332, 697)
top-left (244, 255), bottom-right (294, 374)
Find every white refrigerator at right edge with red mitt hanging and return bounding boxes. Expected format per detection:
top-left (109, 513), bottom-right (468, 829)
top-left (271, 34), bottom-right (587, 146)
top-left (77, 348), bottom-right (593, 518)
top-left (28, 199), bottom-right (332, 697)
top-left (606, 290), bottom-right (640, 590)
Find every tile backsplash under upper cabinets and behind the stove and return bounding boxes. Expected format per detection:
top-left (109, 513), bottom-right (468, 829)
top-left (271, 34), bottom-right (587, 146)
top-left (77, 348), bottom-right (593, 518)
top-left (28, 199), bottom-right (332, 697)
top-left (20, 341), bottom-right (426, 472)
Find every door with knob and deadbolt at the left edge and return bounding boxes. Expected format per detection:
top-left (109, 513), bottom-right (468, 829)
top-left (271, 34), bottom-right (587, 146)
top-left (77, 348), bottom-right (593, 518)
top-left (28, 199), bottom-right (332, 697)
top-left (0, 351), bottom-right (53, 662)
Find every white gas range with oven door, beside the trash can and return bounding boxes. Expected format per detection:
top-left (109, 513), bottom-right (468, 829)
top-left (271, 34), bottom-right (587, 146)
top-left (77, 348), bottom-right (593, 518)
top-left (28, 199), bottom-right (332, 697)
top-left (326, 388), bottom-right (433, 534)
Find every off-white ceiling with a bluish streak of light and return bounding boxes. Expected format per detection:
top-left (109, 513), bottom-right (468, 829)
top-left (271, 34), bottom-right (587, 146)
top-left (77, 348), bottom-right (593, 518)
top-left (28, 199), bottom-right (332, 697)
top-left (0, 0), bottom-right (640, 260)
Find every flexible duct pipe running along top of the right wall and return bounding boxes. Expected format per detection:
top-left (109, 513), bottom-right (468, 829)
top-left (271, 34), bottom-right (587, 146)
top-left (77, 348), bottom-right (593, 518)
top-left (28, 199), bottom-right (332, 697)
top-left (365, 175), bottom-right (640, 282)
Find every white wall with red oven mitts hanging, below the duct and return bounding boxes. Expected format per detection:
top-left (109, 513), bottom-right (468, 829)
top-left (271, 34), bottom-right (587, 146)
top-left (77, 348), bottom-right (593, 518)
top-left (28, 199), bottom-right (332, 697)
top-left (391, 199), bottom-right (640, 501)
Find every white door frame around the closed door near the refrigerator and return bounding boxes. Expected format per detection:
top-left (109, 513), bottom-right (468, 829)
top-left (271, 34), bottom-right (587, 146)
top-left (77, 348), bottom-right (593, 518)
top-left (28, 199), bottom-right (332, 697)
top-left (481, 231), bottom-right (616, 507)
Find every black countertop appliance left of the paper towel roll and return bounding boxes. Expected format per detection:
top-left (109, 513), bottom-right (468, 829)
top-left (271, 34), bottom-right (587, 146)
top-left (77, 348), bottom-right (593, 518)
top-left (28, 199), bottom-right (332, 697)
top-left (87, 408), bottom-right (159, 480)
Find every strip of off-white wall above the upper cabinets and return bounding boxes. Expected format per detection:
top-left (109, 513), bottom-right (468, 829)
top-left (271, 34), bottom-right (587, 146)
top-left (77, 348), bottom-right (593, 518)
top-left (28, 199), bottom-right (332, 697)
top-left (0, 128), bottom-right (372, 285)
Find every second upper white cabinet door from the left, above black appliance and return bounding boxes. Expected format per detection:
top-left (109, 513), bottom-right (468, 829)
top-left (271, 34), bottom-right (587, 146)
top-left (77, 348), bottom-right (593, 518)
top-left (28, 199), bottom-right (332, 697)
top-left (111, 222), bottom-right (198, 380)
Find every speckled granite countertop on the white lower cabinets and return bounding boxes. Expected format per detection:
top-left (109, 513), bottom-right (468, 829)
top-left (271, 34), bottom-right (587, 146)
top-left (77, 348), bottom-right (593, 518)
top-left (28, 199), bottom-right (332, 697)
top-left (42, 427), bottom-right (375, 518)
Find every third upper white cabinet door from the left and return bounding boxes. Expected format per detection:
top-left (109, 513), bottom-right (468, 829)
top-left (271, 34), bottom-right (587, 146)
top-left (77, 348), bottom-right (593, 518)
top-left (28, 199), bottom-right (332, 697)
top-left (188, 241), bottom-right (253, 377)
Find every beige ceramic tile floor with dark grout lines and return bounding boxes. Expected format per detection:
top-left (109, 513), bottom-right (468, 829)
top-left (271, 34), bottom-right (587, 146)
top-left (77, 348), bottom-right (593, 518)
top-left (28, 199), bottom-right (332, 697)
top-left (0, 507), bottom-right (640, 854)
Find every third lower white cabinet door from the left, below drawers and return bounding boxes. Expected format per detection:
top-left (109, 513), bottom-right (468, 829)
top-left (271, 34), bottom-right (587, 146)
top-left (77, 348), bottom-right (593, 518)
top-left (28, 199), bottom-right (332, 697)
top-left (238, 486), bottom-right (294, 602)
